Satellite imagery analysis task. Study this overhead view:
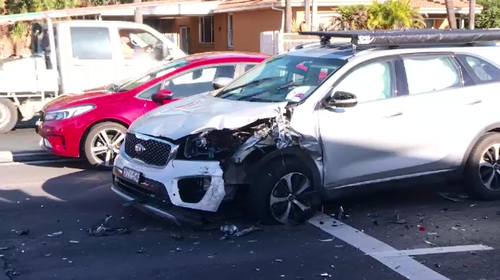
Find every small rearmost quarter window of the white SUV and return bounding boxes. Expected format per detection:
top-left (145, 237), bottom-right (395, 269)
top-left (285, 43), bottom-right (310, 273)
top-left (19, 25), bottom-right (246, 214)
top-left (457, 55), bottom-right (500, 84)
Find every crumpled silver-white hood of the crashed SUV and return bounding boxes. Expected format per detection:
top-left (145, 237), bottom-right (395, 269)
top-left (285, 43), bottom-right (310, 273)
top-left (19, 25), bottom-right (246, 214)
top-left (129, 93), bottom-right (287, 140)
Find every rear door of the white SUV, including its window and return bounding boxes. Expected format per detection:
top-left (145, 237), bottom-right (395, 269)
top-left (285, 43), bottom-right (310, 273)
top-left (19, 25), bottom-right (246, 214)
top-left (394, 53), bottom-right (486, 173)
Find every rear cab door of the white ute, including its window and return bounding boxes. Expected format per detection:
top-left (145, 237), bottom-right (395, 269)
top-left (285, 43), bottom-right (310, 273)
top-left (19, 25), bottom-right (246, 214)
top-left (65, 26), bottom-right (117, 92)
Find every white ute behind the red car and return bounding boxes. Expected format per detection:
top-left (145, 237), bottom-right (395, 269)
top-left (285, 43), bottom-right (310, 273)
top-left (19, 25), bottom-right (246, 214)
top-left (0, 9), bottom-right (186, 133)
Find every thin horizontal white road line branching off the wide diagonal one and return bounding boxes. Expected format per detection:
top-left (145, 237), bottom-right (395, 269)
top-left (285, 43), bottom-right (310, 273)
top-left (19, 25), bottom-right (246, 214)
top-left (370, 245), bottom-right (493, 257)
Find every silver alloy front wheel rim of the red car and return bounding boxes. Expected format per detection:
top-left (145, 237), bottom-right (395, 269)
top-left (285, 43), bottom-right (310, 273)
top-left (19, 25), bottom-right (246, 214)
top-left (91, 129), bottom-right (125, 167)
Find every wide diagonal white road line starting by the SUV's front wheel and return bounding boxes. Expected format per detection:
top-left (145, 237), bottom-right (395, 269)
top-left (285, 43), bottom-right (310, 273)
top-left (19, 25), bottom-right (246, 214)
top-left (309, 213), bottom-right (450, 280)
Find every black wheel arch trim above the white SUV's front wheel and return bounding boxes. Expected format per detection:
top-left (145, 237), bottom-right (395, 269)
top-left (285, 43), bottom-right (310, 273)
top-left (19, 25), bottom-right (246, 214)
top-left (245, 146), bottom-right (322, 192)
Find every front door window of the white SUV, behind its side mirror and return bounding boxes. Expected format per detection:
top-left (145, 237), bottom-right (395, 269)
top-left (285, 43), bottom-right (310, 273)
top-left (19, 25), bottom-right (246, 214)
top-left (333, 61), bottom-right (393, 102)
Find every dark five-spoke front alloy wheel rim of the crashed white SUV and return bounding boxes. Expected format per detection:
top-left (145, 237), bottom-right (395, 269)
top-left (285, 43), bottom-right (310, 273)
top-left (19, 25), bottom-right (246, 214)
top-left (269, 172), bottom-right (312, 224)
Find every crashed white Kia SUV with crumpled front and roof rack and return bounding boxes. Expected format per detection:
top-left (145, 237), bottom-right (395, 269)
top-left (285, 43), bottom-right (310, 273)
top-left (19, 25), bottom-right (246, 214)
top-left (112, 30), bottom-right (500, 226)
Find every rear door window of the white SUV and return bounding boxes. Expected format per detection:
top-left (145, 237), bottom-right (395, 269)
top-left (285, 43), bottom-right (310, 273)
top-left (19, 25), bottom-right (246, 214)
top-left (403, 56), bottom-right (462, 95)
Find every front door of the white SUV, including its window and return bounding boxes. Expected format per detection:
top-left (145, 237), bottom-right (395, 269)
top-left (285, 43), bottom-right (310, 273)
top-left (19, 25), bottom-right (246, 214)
top-left (318, 58), bottom-right (440, 188)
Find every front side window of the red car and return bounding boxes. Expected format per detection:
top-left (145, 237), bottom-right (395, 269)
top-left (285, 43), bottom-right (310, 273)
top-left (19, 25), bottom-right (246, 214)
top-left (164, 64), bottom-right (236, 98)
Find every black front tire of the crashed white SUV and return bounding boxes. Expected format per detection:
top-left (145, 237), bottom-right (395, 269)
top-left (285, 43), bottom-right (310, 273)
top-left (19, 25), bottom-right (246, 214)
top-left (247, 158), bottom-right (316, 224)
